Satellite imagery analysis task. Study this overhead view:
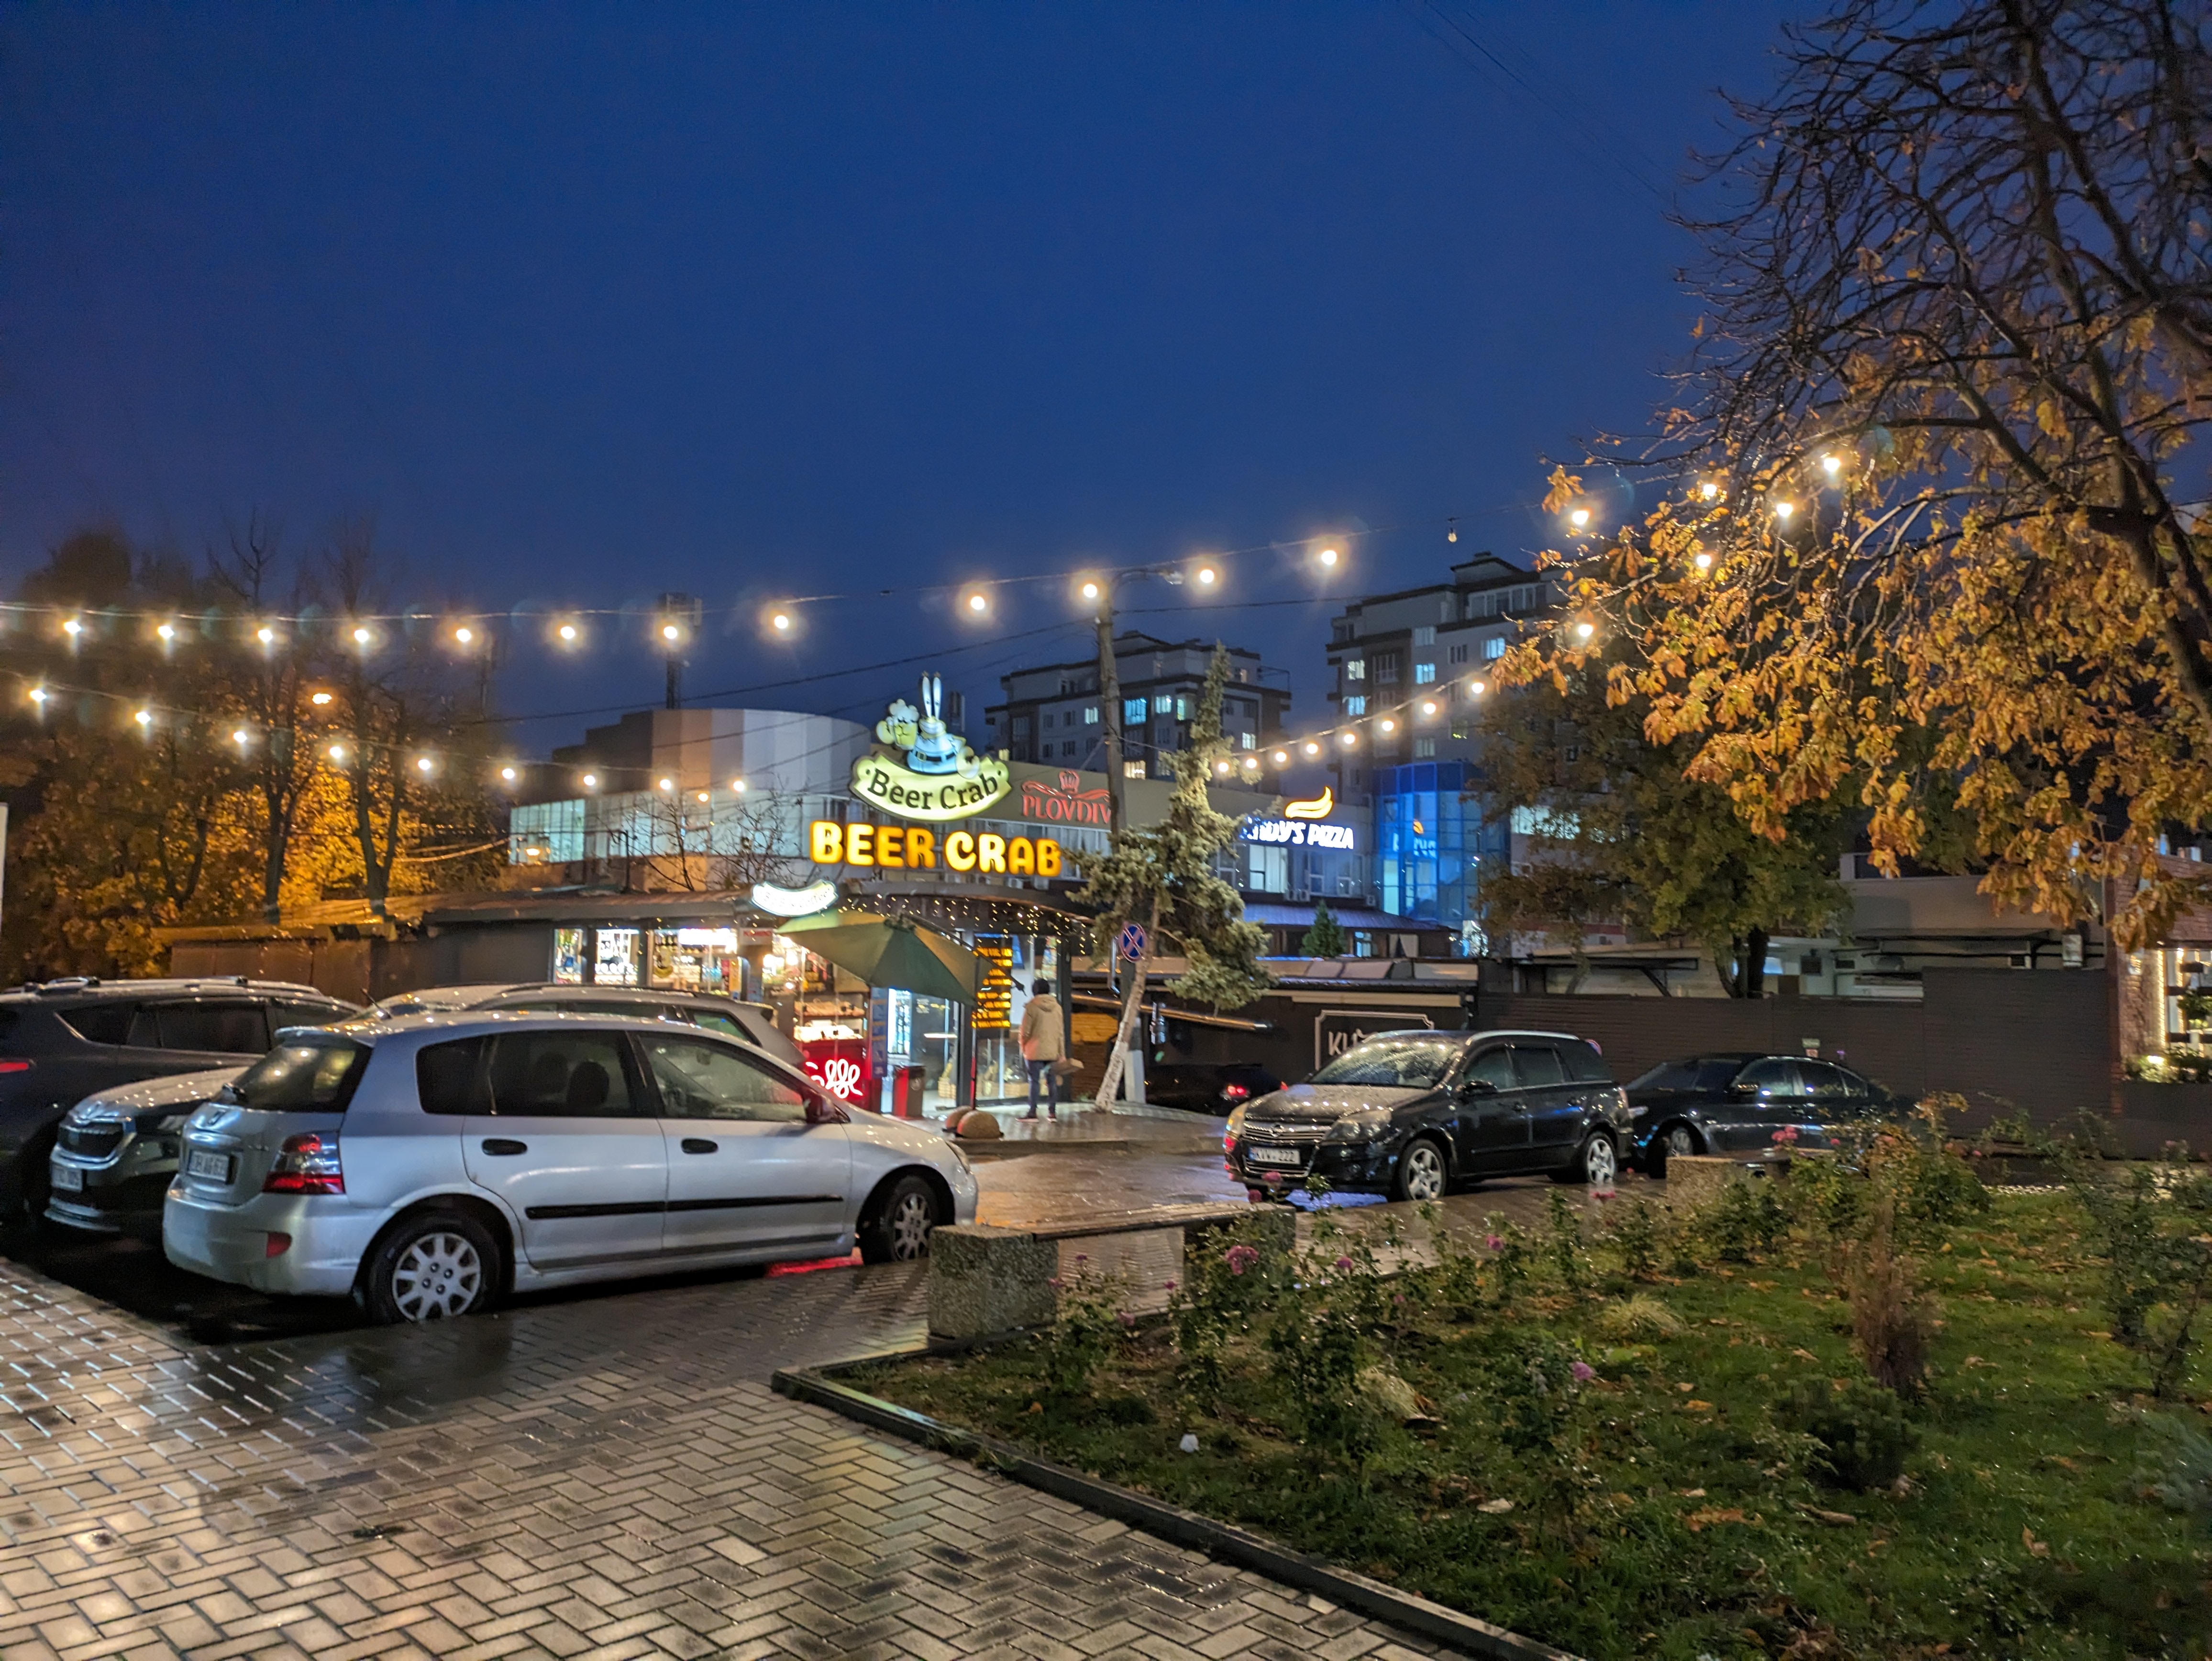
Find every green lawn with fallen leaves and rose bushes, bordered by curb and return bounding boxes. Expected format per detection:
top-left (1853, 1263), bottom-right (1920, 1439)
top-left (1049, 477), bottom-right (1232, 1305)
top-left (852, 1195), bottom-right (2212, 1661)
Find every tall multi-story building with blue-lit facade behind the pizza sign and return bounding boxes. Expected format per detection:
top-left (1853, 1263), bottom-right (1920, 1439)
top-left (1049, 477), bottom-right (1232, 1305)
top-left (1329, 553), bottom-right (1559, 949)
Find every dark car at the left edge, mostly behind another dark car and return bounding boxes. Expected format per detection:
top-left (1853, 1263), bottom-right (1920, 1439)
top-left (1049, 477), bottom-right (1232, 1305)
top-left (0, 977), bottom-right (354, 1225)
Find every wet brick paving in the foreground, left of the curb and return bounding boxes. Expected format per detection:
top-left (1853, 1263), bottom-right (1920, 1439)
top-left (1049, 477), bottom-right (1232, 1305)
top-left (0, 1265), bottom-right (1460, 1661)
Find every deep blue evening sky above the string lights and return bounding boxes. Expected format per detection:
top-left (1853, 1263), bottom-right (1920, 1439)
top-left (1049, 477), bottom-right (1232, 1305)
top-left (0, 0), bottom-right (1781, 748)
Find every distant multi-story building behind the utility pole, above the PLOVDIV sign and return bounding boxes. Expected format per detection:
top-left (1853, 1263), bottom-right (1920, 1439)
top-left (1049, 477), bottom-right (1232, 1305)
top-left (984, 631), bottom-right (1290, 778)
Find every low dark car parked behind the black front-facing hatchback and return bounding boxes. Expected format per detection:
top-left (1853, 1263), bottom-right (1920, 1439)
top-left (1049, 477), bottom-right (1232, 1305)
top-left (1628, 1053), bottom-right (1911, 1177)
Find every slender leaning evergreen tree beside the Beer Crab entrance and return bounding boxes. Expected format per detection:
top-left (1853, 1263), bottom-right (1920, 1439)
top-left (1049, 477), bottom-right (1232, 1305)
top-left (1080, 642), bottom-right (1274, 1106)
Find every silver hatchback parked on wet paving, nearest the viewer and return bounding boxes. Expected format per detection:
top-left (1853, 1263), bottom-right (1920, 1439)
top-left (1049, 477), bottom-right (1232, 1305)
top-left (162, 1011), bottom-right (975, 1320)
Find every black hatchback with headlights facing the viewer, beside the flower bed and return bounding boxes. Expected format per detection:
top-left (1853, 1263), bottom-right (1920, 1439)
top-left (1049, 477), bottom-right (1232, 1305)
top-left (1226, 1029), bottom-right (1628, 1199)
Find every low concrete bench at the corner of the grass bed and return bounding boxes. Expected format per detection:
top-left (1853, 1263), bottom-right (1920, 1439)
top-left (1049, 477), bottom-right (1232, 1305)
top-left (929, 1206), bottom-right (1298, 1342)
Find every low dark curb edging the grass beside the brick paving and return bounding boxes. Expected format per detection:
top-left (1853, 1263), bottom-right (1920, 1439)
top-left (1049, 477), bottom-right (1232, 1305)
top-left (770, 1351), bottom-right (1577, 1661)
